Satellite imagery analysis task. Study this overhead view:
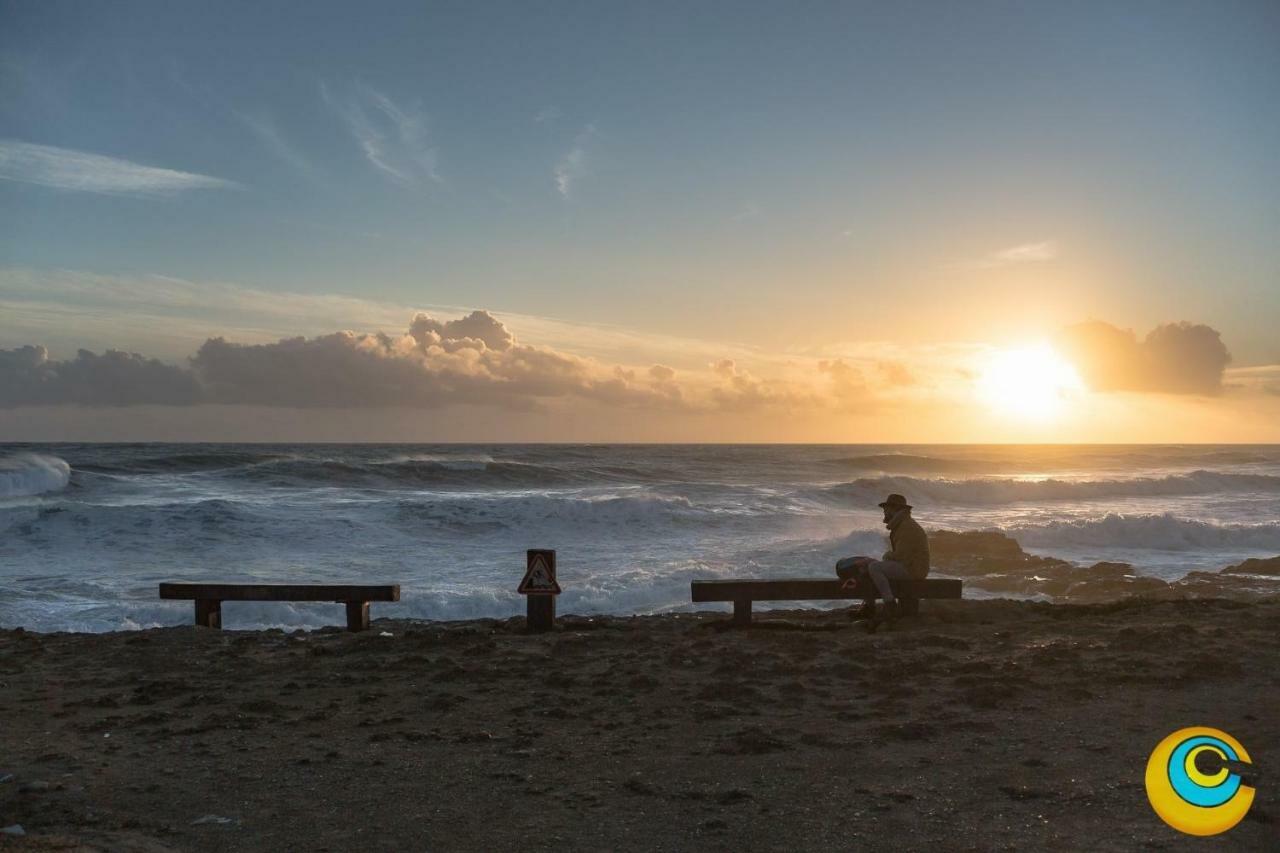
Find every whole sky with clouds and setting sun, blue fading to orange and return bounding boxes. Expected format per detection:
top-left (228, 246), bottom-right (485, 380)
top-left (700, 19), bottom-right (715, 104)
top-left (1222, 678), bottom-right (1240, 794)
top-left (0, 0), bottom-right (1280, 442)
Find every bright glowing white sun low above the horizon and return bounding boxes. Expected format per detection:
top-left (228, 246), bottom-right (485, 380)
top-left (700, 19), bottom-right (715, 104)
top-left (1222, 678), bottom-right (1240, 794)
top-left (978, 343), bottom-right (1084, 423)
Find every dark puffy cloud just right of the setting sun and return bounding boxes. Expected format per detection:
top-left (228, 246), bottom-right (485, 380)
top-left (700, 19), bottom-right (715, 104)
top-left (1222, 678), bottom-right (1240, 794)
top-left (1059, 320), bottom-right (1231, 394)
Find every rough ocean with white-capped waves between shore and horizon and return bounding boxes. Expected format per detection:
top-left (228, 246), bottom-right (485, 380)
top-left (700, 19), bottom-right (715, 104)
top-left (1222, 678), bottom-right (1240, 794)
top-left (0, 444), bottom-right (1280, 631)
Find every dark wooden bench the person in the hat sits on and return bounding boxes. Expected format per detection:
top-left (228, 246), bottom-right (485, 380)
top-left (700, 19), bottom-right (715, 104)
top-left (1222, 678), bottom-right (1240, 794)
top-left (690, 578), bottom-right (961, 625)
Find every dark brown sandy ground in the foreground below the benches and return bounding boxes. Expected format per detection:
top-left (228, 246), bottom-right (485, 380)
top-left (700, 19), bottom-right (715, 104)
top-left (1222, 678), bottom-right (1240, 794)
top-left (0, 598), bottom-right (1280, 850)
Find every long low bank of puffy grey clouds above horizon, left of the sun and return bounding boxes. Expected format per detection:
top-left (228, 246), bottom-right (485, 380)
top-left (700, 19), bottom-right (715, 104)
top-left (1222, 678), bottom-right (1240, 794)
top-left (0, 311), bottom-right (890, 412)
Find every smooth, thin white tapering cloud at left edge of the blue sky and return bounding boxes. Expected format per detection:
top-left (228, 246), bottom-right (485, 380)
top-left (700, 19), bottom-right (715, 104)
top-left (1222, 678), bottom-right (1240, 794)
top-left (0, 140), bottom-right (239, 196)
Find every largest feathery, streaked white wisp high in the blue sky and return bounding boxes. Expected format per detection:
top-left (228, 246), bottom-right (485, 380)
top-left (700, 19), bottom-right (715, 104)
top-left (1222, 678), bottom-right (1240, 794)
top-left (320, 82), bottom-right (440, 186)
